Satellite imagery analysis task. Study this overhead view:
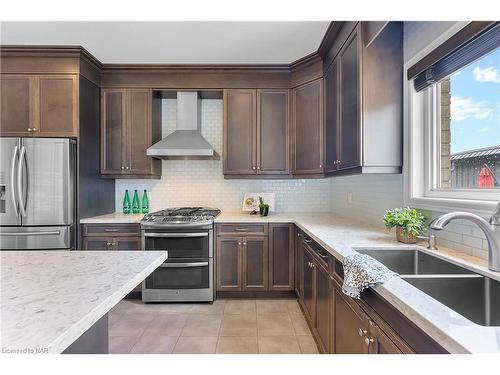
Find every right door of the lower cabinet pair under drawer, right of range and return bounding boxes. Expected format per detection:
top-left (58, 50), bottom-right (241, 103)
top-left (242, 237), bottom-right (268, 291)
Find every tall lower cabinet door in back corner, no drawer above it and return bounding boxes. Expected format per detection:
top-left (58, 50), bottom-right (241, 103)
top-left (269, 223), bottom-right (294, 290)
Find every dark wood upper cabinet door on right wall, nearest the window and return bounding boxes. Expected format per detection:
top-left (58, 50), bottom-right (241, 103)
top-left (334, 27), bottom-right (361, 169)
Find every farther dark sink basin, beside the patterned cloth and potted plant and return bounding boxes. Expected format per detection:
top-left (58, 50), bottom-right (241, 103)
top-left (357, 249), bottom-right (474, 275)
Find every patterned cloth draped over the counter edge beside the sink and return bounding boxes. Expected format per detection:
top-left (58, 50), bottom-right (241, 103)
top-left (342, 254), bottom-right (397, 299)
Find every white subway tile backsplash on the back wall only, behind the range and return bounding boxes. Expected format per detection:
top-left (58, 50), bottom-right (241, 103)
top-left (116, 99), bottom-right (331, 212)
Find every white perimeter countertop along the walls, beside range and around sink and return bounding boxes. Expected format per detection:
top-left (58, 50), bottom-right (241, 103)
top-left (82, 212), bottom-right (500, 353)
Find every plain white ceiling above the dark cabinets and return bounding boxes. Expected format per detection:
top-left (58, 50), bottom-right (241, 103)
top-left (0, 21), bottom-right (329, 64)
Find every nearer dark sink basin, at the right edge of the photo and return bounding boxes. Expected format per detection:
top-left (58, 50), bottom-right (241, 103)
top-left (402, 274), bottom-right (500, 326)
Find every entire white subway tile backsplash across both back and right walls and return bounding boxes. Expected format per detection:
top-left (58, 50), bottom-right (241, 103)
top-left (116, 99), bottom-right (488, 258)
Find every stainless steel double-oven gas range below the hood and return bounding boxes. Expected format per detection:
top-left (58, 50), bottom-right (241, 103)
top-left (141, 207), bottom-right (220, 302)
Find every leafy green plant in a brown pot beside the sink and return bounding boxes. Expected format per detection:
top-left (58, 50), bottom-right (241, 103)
top-left (384, 207), bottom-right (426, 243)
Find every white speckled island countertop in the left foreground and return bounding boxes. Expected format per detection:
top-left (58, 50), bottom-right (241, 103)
top-left (0, 250), bottom-right (167, 353)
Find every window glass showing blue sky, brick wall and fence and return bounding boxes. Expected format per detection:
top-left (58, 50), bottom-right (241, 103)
top-left (438, 49), bottom-right (500, 189)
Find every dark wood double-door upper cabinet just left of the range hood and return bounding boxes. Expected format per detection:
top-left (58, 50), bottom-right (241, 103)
top-left (101, 89), bottom-right (161, 178)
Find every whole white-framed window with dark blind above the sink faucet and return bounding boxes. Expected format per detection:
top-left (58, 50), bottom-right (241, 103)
top-left (405, 23), bottom-right (500, 213)
